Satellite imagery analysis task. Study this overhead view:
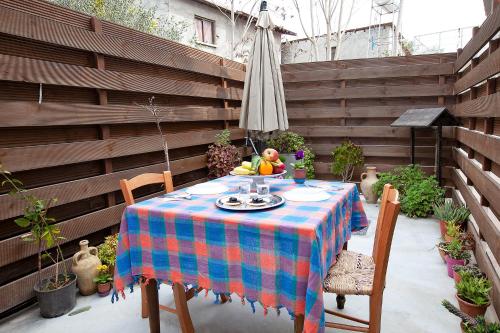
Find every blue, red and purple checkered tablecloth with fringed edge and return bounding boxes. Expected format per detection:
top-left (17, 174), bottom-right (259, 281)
top-left (114, 176), bottom-right (368, 332)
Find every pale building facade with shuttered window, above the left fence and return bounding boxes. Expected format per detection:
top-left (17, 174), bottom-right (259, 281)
top-left (143, 0), bottom-right (295, 62)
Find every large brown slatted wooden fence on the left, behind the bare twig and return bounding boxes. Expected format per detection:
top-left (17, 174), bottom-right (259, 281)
top-left (0, 0), bottom-right (244, 316)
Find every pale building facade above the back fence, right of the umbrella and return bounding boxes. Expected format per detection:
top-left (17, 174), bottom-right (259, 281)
top-left (281, 23), bottom-right (401, 64)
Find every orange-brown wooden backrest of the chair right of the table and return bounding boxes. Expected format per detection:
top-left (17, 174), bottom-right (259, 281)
top-left (373, 184), bottom-right (400, 292)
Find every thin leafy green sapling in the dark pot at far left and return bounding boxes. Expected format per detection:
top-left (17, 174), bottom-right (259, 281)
top-left (0, 164), bottom-right (72, 291)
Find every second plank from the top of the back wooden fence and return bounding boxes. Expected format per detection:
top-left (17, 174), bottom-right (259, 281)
top-left (282, 63), bottom-right (453, 83)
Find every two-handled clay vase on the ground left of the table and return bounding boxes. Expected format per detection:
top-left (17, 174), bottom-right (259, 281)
top-left (71, 240), bottom-right (101, 296)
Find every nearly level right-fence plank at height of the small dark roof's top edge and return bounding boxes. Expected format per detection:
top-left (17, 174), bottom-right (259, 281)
top-left (450, 92), bottom-right (500, 117)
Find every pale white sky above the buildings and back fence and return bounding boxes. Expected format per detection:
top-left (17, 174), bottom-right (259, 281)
top-left (258, 0), bottom-right (486, 51)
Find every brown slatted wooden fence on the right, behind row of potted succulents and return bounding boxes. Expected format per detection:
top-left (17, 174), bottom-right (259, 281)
top-left (451, 1), bottom-right (500, 316)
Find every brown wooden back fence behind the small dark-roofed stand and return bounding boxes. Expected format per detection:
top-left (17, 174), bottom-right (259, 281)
top-left (282, 54), bottom-right (456, 181)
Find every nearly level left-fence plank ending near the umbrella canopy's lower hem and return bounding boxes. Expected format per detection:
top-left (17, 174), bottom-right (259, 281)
top-left (0, 101), bottom-right (240, 127)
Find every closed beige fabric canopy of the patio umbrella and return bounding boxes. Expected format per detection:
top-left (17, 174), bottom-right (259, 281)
top-left (240, 1), bottom-right (288, 133)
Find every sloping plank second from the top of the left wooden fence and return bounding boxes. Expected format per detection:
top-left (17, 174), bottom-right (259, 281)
top-left (0, 6), bottom-right (245, 81)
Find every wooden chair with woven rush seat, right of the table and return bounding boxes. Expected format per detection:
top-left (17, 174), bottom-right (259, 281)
top-left (324, 184), bottom-right (400, 333)
